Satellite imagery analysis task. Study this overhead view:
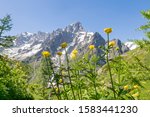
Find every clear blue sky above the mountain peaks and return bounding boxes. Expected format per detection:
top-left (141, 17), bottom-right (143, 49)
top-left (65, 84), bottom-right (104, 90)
top-left (0, 0), bottom-right (150, 41)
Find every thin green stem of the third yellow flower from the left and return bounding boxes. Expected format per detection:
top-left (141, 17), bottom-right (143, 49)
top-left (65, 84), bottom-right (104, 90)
top-left (65, 49), bottom-right (76, 100)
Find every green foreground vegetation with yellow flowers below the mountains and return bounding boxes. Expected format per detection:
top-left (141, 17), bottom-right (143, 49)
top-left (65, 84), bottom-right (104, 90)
top-left (0, 10), bottom-right (150, 100)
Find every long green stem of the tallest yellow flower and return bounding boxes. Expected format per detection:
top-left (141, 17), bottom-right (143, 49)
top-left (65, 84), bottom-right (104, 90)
top-left (106, 34), bottom-right (116, 99)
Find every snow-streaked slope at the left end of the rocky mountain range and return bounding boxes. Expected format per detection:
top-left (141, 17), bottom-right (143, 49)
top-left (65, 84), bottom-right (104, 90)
top-left (3, 32), bottom-right (49, 60)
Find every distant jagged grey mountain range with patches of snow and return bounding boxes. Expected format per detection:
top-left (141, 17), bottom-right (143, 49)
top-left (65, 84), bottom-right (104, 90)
top-left (3, 22), bottom-right (137, 61)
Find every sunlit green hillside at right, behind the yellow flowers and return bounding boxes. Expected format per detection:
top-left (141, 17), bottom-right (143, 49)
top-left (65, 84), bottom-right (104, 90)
top-left (99, 48), bottom-right (150, 99)
